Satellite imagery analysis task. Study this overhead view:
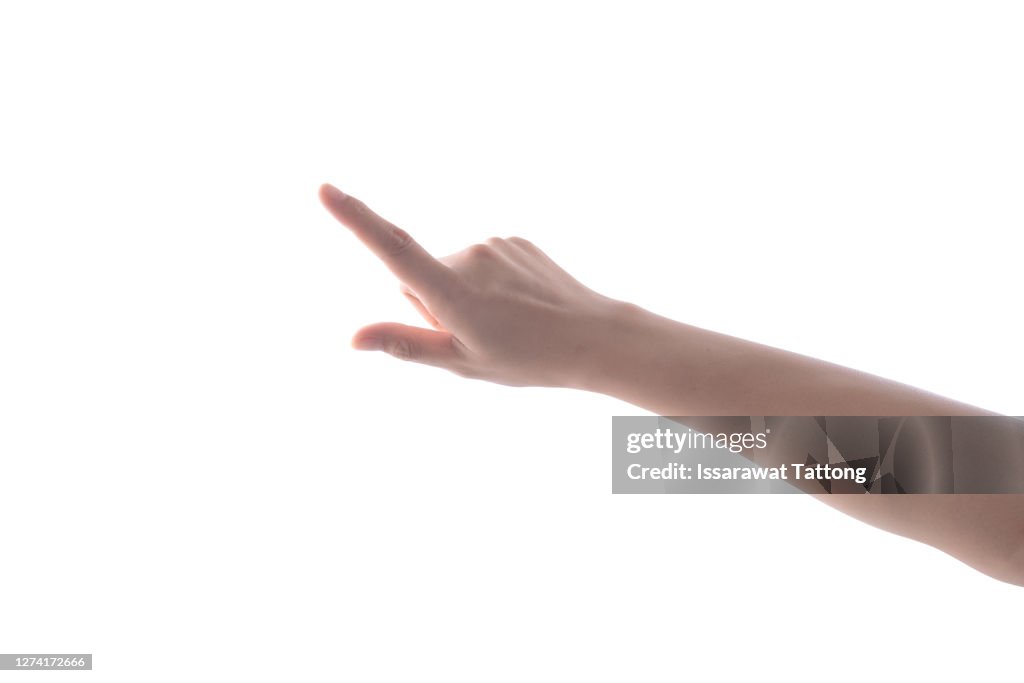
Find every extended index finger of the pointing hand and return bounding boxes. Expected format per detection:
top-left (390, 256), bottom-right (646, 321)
top-left (319, 183), bottom-right (455, 296)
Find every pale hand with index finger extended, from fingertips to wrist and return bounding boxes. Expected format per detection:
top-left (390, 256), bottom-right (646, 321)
top-left (319, 184), bottom-right (625, 386)
